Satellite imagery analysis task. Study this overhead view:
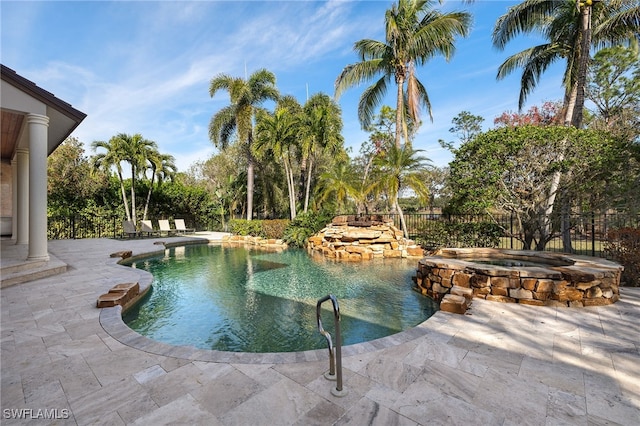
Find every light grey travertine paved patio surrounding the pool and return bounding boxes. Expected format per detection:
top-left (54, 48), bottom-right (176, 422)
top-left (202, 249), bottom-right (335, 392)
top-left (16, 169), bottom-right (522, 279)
top-left (0, 237), bottom-right (640, 426)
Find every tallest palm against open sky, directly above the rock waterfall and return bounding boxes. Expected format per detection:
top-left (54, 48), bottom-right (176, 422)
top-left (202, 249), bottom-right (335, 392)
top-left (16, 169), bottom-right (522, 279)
top-left (335, 0), bottom-right (471, 148)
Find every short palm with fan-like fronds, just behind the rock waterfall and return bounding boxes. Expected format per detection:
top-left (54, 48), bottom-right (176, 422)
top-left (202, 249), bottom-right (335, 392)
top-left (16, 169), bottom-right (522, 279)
top-left (373, 144), bottom-right (430, 238)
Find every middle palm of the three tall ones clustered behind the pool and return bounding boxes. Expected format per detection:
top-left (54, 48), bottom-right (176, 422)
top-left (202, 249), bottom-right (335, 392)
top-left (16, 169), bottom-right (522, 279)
top-left (255, 97), bottom-right (300, 220)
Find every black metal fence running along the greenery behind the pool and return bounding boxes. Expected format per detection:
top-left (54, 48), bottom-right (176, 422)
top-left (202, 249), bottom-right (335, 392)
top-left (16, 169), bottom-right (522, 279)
top-left (48, 213), bottom-right (640, 257)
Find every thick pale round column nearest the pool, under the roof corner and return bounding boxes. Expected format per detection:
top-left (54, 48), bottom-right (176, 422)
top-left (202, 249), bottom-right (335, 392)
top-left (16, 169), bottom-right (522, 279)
top-left (27, 114), bottom-right (49, 260)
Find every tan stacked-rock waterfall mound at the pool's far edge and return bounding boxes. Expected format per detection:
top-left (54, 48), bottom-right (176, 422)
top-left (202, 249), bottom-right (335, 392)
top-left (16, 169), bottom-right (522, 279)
top-left (307, 215), bottom-right (424, 261)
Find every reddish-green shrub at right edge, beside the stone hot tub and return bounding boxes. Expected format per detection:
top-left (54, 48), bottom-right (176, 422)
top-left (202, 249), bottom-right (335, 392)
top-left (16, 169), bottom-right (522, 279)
top-left (604, 228), bottom-right (640, 287)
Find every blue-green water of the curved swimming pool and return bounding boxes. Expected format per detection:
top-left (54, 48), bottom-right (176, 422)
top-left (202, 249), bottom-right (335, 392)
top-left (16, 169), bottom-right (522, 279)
top-left (123, 245), bottom-right (438, 352)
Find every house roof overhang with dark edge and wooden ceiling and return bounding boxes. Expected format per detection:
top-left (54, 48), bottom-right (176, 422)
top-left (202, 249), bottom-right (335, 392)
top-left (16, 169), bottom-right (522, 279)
top-left (0, 64), bottom-right (87, 161)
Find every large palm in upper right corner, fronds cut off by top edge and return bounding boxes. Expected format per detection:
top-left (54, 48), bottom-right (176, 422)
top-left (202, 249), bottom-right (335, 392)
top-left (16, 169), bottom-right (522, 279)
top-left (493, 0), bottom-right (640, 127)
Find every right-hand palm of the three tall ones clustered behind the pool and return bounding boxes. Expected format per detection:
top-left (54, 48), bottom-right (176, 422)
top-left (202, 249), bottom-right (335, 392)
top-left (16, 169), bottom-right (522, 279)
top-left (300, 93), bottom-right (344, 213)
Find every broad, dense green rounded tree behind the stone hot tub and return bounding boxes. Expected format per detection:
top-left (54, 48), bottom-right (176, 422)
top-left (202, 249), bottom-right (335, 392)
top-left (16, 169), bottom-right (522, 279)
top-left (449, 125), bottom-right (621, 250)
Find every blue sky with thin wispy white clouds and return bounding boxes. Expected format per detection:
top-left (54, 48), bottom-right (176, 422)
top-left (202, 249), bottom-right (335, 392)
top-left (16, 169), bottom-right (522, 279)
top-left (0, 0), bottom-right (563, 171)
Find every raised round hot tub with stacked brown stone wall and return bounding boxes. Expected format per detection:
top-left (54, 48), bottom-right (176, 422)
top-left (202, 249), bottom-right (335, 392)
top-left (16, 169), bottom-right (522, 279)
top-left (415, 248), bottom-right (623, 307)
